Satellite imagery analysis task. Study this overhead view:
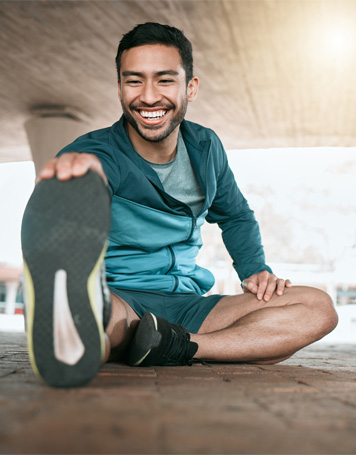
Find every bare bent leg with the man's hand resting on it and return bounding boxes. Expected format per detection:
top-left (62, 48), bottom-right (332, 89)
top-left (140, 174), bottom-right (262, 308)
top-left (191, 286), bottom-right (337, 363)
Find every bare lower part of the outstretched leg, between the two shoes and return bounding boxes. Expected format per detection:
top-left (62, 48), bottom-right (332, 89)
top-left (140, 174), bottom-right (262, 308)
top-left (104, 293), bottom-right (139, 363)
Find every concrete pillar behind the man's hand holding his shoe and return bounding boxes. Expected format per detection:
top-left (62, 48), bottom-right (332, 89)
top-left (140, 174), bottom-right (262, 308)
top-left (25, 106), bottom-right (88, 174)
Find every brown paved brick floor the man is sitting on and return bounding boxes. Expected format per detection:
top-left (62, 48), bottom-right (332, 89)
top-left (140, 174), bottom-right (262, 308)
top-left (0, 333), bottom-right (356, 454)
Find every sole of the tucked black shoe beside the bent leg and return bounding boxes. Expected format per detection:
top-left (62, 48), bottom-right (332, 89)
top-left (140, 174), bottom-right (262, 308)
top-left (129, 313), bottom-right (162, 366)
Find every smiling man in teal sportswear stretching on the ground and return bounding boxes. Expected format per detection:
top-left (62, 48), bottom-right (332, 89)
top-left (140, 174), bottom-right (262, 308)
top-left (22, 23), bottom-right (337, 387)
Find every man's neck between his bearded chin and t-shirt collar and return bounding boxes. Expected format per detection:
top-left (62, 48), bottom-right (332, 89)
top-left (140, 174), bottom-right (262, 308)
top-left (127, 123), bottom-right (179, 163)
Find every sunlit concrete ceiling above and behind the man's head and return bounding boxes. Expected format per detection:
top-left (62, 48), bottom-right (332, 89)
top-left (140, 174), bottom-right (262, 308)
top-left (0, 0), bottom-right (356, 162)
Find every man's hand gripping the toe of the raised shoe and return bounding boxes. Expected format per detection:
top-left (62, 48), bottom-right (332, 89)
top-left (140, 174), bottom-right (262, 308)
top-left (36, 152), bottom-right (108, 184)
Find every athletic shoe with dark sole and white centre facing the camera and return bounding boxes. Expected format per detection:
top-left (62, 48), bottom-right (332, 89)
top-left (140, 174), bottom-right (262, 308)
top-left (21, 171), bottom-right (111, 387)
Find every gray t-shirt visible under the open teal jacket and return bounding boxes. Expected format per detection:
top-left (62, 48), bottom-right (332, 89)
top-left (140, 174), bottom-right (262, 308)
top-left (147, 131), bottom-right (205, 216)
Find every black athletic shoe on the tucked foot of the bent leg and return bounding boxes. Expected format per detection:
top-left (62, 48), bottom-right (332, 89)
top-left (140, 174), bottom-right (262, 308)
top-left (129, 313), bottom-right (198, 367)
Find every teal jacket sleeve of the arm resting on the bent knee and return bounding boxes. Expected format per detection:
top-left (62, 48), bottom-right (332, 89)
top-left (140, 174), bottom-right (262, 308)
top-left (206, 141), bottom-right (272, 281)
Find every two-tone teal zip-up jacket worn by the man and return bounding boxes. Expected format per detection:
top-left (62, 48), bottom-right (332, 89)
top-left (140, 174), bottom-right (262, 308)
top-left (58, 117), bottom-right (271, 294)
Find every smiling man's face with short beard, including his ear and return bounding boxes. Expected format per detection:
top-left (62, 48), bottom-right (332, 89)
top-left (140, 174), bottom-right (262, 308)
top-left (119, 44), bottom-right (198, 142)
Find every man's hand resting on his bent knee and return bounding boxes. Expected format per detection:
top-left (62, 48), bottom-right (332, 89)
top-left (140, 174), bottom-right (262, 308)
top-left (243, 271), bottom-right (292, 302)
